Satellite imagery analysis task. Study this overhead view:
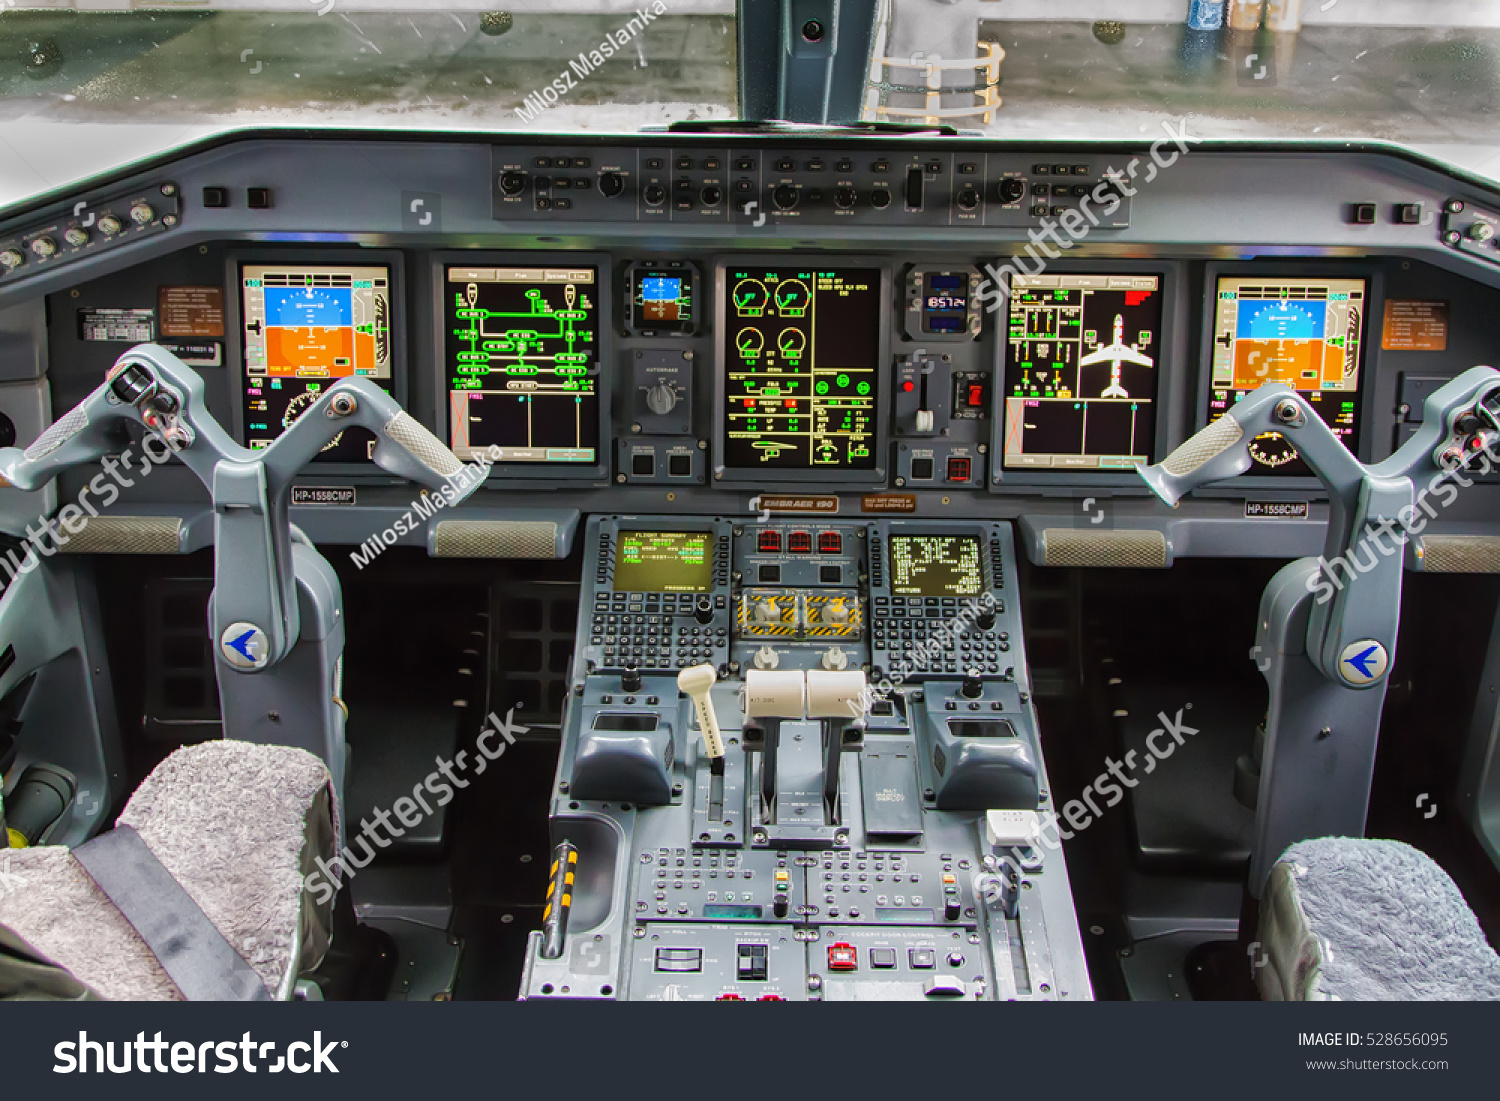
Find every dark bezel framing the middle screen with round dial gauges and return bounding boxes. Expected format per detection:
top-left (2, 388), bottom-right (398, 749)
top-left (714, 258), bottom-right (893, 489)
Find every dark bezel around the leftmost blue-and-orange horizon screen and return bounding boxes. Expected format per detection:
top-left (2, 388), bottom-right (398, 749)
top-left (224, 248), bottom-right (410, 482)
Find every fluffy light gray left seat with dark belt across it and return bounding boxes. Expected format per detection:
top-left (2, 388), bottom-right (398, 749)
top-left (0, 741), bottom-right (339, 1001)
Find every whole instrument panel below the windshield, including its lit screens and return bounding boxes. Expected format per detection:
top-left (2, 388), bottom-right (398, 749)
top-left (0, 135), bottom-right (1500, 570)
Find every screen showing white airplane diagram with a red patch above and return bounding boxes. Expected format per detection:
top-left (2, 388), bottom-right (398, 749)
top-left (1004, 275), bottom-right (1164, 470)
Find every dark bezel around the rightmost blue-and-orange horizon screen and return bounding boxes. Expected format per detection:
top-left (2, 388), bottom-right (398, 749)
top-left (1188, 258), bottom-right (1385, 498)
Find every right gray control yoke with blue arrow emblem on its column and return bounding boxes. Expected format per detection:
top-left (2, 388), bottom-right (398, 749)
top-left (1139, 368), bottom-right (1500, 689)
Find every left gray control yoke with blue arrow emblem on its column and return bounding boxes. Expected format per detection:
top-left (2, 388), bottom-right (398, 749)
top-left (0, 344), bottom-right (483, 672)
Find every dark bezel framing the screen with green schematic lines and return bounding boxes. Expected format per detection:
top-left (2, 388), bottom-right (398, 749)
top-left (428, 251), bottom-right (617, 485)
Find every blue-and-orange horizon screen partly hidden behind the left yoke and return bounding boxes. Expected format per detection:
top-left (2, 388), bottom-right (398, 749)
top-left (240, 264), bottom-right (392, 462)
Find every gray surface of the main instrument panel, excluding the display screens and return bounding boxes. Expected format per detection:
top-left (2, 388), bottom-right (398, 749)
top-left (0, 126), bottom-right (1500, 557)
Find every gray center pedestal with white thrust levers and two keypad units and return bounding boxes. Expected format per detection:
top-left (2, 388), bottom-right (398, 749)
top-left (522, 516), bottom-right (1091, 1001)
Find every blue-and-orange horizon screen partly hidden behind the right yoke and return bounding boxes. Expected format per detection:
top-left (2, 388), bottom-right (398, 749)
top-left (1209, 276), bottom-right (1367, 476)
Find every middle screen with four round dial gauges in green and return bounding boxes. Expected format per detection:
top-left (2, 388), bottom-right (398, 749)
top-left (722, 267), bottom-right (882, 470)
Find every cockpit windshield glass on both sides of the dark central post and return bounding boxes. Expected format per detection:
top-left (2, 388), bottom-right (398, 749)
top-left (0, 0), bottom-right (1500, 203)
